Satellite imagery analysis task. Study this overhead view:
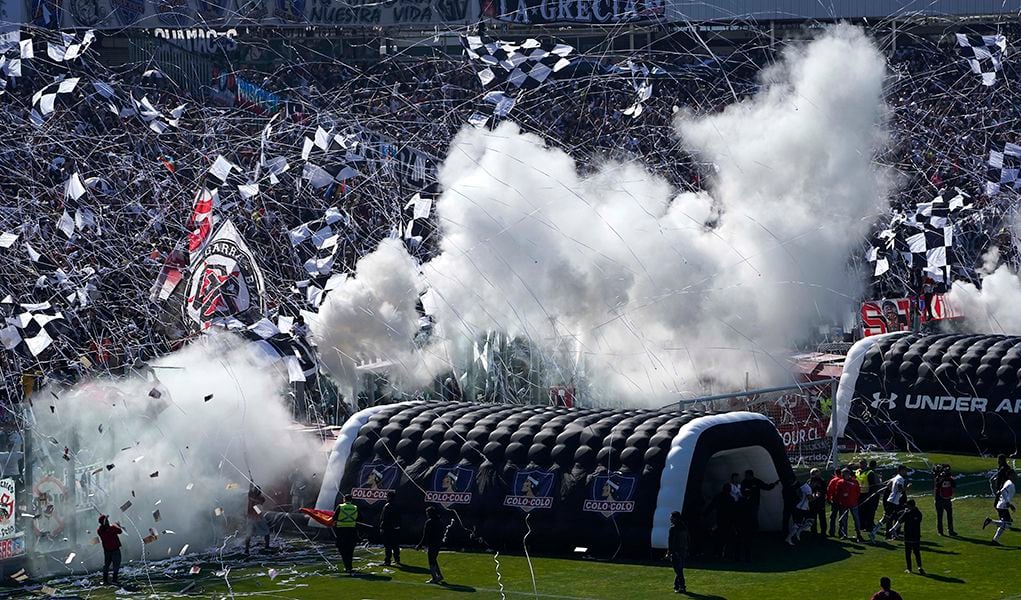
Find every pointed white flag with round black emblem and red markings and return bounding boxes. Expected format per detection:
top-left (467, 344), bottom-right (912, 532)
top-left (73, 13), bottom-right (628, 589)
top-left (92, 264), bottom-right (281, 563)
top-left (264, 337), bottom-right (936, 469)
top-left (185, 220), bottom-right (265, 329)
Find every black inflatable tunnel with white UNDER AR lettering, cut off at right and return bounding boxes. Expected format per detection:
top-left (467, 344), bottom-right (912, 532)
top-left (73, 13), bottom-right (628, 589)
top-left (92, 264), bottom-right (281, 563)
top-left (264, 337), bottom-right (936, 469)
top-left (829, 333), bottom-right (1021, 454)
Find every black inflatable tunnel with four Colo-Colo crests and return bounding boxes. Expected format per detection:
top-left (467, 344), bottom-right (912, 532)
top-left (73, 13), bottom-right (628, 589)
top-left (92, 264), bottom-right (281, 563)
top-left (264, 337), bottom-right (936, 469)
top-left (315, 402), bottom-right (794, 555)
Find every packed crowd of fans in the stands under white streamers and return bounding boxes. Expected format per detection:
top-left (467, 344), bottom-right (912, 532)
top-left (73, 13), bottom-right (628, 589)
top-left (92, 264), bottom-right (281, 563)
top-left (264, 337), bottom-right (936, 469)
top-left (0, 28), bottom-right (1021, 412)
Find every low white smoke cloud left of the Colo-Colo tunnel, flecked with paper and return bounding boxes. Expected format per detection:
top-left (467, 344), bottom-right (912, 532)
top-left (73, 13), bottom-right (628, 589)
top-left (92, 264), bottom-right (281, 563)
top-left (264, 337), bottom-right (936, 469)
top-left (33, 336), bottom-right (324, 574)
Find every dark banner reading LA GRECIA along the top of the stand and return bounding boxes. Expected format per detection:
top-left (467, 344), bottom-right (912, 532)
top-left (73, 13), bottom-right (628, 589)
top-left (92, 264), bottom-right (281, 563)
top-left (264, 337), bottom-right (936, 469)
top-left (480, 0), bottom-right (667, 24)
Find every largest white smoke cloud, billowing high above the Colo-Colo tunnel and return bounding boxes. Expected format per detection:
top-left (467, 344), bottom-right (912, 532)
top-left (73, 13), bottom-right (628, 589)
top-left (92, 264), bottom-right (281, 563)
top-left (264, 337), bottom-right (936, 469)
top-left (314, 27), bottom-right (886, 401)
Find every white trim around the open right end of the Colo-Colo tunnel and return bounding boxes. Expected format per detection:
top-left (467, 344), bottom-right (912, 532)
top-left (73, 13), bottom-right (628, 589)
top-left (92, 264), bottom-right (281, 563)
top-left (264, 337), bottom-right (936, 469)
top-left (651, 411), bottom-right (769, 548)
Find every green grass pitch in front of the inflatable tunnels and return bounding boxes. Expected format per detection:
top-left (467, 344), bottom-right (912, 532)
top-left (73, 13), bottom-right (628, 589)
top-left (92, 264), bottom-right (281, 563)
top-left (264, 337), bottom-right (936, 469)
top-left (15, 457), bottom-right (1021, 600)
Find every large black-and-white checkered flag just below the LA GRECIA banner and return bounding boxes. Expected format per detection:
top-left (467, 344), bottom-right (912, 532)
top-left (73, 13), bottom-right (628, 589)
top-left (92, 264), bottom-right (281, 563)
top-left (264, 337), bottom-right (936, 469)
top-left (460, 36), bottom-right (574, 90)
